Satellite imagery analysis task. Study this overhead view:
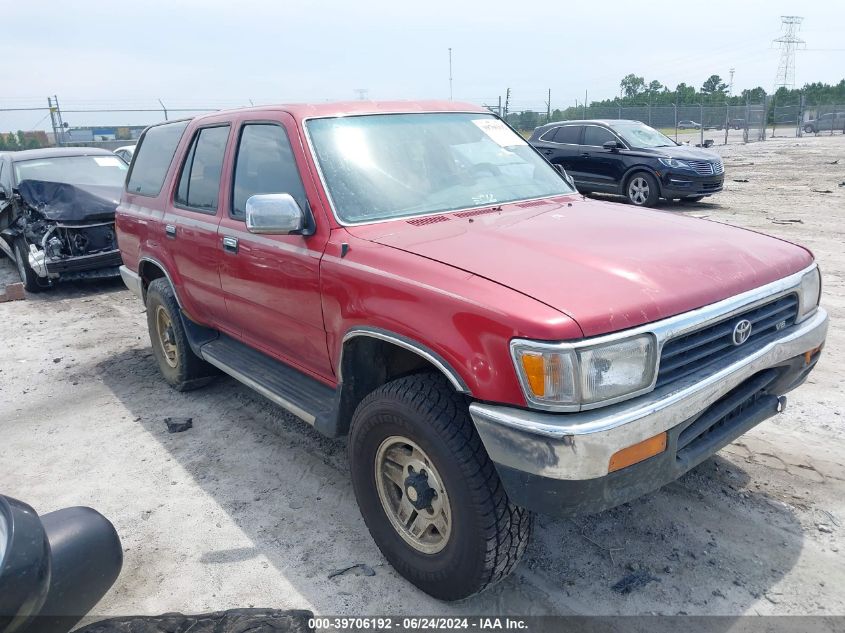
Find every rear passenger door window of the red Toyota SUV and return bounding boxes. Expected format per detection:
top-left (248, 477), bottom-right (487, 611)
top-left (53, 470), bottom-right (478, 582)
top-left (175, 125), bottom-right (229, 213)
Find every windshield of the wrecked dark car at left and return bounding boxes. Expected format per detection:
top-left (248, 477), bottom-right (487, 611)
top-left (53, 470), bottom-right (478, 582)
top-left (15, 156), bottom-right (128, 187)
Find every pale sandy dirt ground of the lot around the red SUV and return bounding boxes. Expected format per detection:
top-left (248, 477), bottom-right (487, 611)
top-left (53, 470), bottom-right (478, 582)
top-left (0, 136), bottom-right (845, 615)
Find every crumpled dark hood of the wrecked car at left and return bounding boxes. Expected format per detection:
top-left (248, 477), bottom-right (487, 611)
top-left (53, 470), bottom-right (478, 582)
top-left (18, 180), bottom-right (121, 222)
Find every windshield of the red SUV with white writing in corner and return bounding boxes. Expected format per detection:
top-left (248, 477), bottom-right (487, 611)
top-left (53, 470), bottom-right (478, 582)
top-left (307, 113), bottom-right (573, 223)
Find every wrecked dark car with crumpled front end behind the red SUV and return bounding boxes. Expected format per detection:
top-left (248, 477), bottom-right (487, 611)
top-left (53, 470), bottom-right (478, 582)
top-left (0, 147), bottom-right (128, 292)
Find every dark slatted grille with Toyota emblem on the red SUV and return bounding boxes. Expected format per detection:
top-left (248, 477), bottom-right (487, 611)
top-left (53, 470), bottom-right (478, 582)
top-left (657, 294), bottom-right (798, 387)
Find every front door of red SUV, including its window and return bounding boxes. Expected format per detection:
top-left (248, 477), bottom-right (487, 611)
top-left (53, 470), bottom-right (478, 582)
top-left (219, 113), bottom-right (332, 378)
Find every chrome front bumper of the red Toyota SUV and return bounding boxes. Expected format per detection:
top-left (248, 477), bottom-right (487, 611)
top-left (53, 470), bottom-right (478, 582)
top-left (469, 308), bottom-right (828, 480)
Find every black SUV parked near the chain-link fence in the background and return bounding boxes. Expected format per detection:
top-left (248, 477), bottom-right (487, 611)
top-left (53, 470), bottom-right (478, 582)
top-left (529, 120), bottom-right (725, 207)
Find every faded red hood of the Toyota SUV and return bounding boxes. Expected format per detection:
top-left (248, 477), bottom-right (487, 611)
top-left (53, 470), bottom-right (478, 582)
top-left (347, 196), bottom-right (813, 336)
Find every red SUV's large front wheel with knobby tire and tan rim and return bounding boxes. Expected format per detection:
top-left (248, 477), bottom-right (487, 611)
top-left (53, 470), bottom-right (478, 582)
top-left (348, 374), bottom-right (533, 600)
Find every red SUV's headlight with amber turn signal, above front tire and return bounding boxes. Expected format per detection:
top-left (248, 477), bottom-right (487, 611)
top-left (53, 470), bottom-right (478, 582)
top-left (511, 334), bottom-right (657, 408)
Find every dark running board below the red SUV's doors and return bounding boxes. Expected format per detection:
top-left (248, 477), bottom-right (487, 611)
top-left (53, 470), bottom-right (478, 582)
top-left (199, 334), bottom-right (337, 432)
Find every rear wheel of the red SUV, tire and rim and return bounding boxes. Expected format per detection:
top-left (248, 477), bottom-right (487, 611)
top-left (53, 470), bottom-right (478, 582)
top-left (147, 277), bottom-right (218, 391)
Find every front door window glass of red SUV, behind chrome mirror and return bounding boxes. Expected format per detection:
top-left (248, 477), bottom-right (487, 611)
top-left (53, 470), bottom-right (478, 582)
top-left (232, 123), bottom-right (307, 220)
